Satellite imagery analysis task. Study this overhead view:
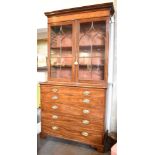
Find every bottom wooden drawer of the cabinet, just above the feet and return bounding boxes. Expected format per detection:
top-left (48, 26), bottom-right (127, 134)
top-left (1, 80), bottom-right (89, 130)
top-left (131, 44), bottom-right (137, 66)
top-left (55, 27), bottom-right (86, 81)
top-left (41, 121), bottom-right (103, 144)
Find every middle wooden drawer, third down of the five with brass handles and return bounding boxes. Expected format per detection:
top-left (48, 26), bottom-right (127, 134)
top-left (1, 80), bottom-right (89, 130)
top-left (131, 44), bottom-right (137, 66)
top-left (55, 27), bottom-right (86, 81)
top-left (41, 102), bottom-right (104, 119)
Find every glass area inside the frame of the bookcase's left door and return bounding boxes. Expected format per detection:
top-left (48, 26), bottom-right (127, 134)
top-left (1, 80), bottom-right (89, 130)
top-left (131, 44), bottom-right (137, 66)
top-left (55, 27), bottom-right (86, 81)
top-left (50, 24), bottom-right (72, 79)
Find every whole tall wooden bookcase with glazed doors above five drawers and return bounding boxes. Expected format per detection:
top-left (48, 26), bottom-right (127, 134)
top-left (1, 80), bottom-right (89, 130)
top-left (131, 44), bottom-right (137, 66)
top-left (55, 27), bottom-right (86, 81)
top-left (40, 3), bottom-right (114, 151)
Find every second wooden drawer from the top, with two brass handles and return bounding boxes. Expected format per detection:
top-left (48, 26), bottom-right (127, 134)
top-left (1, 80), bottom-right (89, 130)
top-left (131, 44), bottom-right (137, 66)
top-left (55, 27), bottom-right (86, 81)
top-left (41, 92), bottom-right (104, 108)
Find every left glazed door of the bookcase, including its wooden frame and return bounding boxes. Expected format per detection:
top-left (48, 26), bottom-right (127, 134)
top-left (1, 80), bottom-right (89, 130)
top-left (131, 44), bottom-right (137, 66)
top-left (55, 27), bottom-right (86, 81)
top-left (48, 22), bottom-right (74, 81)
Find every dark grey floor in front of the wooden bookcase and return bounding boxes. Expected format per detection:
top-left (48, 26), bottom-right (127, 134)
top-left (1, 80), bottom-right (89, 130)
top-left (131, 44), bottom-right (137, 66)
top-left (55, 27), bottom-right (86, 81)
top-left (37, 135), bottom-right (110, 155)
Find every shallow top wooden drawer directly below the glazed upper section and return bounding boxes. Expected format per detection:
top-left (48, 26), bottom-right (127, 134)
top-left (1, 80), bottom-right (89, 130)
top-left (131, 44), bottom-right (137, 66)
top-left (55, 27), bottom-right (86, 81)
top-left (41, 85), bottom-right (105, 97)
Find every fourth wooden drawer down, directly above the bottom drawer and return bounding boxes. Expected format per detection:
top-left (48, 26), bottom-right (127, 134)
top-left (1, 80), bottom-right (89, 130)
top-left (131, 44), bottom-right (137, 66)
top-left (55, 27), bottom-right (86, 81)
top-left (42, 112), bottom-right (104, 131)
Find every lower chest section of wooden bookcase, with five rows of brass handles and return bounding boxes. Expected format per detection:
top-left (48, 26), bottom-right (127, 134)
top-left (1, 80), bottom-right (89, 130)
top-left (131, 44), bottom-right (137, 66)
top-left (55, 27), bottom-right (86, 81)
top-left (41, 84), bottom-right (105, 152)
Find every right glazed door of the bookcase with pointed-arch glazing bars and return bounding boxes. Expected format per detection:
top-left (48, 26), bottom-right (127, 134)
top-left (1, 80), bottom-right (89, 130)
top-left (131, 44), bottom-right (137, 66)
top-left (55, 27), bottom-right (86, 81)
top-left (78, 18), bottom-right (108, 82)
